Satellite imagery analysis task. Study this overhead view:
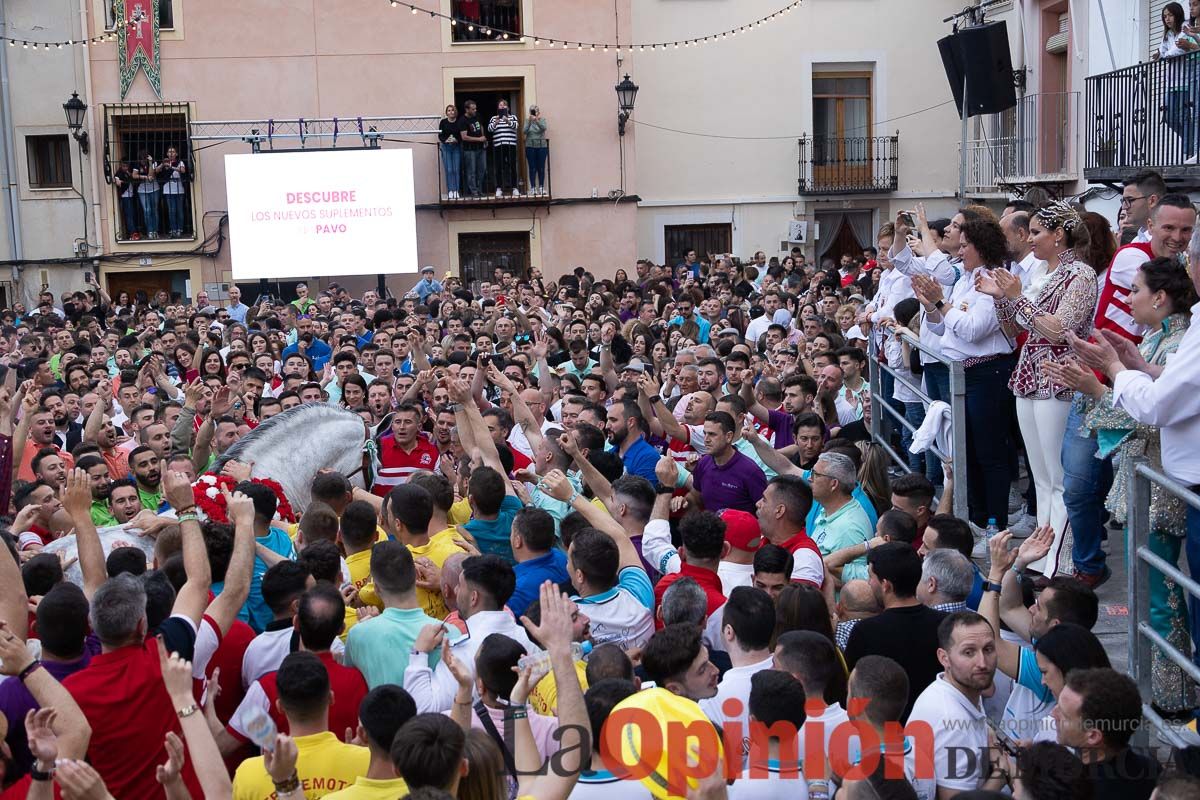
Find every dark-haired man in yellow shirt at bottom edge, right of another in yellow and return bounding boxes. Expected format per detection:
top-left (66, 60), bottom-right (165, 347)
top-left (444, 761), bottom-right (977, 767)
top-left (325, 681), bottom-right (416, 800)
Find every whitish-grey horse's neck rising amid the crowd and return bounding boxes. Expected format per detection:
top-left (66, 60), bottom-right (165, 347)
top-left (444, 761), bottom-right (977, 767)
top-left (211, 403), bottom-right (367, 513)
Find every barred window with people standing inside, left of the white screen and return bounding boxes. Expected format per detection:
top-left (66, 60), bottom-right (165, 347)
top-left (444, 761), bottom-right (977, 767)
top-left (104, 103), bottom-right (196, 241)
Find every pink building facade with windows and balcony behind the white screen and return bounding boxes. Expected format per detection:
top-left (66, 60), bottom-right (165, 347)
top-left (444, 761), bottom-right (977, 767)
top-left (70, 0), bottom-right (636, 300)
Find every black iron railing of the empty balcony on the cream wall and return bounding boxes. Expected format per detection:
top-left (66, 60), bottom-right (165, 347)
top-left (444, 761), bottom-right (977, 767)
top-left (799, 136), bottom-right (900, 194)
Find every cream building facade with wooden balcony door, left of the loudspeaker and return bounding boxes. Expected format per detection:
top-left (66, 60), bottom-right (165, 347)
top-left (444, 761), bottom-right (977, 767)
top-left (634, 0), bottom-right (962, 268)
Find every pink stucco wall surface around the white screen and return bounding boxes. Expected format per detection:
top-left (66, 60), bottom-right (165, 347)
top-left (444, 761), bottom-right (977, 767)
top-left (89, 0), bottom-right (636, 285)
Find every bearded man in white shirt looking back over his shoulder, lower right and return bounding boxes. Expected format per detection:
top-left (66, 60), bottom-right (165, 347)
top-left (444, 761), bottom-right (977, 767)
top-left (907, 612), bottom-right (1007, 798)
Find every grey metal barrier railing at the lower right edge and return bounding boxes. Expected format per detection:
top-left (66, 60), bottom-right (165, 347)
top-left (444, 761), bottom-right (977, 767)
top-left (1126, 458), bottom-right (1200, 747)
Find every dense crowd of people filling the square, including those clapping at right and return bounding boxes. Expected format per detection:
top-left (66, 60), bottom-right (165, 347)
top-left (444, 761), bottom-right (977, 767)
top-left (0, 170), bottom-right (1200, 800)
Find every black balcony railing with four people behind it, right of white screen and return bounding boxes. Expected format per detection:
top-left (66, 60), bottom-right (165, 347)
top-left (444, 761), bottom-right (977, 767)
top-left (438, 139), bottom-right (553, 206)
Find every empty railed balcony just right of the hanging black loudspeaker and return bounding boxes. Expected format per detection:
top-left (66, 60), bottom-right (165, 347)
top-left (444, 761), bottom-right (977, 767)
top-left (966, 91), bottom-right (1079, 196)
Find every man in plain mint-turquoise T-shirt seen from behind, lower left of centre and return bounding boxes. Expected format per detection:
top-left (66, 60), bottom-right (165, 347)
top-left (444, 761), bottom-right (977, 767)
top-left (346, 541), bottom-right (442, 688)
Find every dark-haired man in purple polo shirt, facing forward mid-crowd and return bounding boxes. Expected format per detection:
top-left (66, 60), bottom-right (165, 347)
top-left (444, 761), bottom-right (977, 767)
top-left (688, 411), bottom-right (767, 513)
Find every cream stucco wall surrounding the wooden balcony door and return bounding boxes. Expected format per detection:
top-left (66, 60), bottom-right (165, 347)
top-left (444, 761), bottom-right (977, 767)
top-left (629, 0), bottom-right (962, 258)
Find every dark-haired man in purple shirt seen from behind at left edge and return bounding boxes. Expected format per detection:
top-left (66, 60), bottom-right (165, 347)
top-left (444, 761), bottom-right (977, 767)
top-left (0, 582), bottom-right (100, 780)
